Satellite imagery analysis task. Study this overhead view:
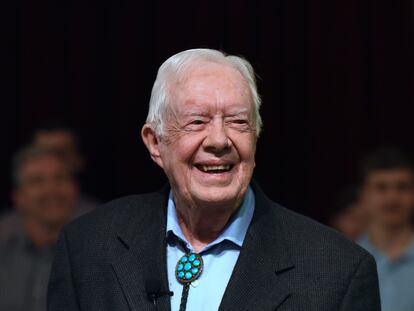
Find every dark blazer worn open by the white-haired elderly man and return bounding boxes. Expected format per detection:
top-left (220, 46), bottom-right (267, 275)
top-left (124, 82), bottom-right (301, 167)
top-left (48, 185), bottom-right (380, 311)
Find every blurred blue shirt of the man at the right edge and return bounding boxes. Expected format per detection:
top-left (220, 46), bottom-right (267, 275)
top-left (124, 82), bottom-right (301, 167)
top-left (358, 236), bottom-right (414, 311)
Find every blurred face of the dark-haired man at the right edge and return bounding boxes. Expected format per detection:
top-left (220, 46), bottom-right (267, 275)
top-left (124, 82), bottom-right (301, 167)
top-left (361, 169), bottom-right (414, 227)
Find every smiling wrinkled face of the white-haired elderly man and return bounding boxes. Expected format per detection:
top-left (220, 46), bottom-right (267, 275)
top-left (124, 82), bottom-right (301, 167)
top-left (143, 62), bottom-right (256, 212)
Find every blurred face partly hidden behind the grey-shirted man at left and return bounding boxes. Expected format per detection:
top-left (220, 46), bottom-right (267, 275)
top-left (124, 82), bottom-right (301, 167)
top-left (34, 130), bottom-right (83, 172)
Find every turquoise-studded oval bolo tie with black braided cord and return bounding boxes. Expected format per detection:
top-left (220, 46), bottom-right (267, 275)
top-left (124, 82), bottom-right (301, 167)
top-left (175, 253), bottom-right (203, 311)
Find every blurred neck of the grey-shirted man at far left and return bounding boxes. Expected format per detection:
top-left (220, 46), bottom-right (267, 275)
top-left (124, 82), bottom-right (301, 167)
top-left (23, 219), bottom-right (61, 248)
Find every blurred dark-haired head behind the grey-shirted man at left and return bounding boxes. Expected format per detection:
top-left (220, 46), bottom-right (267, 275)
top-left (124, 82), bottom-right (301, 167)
top-left (33, 122), bottom-right (84, 173)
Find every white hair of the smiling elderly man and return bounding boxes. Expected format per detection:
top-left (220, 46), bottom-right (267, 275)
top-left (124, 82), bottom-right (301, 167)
top-left (146, 49), bottom-right (263, 137)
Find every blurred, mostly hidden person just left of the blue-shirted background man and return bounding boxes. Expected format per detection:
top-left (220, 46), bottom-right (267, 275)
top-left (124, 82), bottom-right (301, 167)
top-left (329, 186), bottom-right (368, 241)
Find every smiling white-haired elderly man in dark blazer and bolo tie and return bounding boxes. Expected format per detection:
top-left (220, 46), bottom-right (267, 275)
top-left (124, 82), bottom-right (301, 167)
top-left (48, 49), bottom-right (380, 311)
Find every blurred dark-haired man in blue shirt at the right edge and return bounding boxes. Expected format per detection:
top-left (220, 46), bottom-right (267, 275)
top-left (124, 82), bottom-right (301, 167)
top-left (359, 149), bottom-right (414, 311)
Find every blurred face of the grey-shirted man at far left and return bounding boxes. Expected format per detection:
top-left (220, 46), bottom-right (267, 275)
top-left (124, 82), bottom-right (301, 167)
top-left (14, 155), bottom-right (78, 226)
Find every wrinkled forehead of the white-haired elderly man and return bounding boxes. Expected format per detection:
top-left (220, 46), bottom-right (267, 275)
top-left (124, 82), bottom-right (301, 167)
top-left (169, 62), bottom-right (253, 112)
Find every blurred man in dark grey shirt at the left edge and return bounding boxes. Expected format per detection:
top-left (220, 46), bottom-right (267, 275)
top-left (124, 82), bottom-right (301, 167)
top-left (0, 146), bottom-right (78, 311)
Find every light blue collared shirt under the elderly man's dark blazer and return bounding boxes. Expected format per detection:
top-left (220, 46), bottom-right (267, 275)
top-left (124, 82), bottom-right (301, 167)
top-left (167, 187), bottom-right (255, 311)
